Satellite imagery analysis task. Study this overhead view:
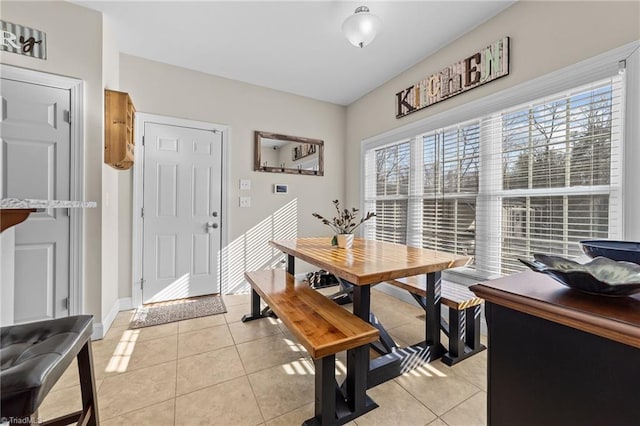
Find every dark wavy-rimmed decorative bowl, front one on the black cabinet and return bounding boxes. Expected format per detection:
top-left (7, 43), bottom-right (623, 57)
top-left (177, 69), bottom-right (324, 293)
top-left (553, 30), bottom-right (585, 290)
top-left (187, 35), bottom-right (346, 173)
top-left (519, 253), bottom-right (640, 296)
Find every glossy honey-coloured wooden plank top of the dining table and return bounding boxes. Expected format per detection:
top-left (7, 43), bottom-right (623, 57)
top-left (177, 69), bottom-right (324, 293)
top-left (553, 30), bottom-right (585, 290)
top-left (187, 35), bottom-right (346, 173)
top-left (269, 237), bottom-right (469, 285)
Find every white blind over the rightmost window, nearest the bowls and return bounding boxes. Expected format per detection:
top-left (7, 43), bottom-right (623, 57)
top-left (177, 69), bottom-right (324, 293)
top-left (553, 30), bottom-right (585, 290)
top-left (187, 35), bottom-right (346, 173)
top-left (476, 76), bottom-right (622, 275)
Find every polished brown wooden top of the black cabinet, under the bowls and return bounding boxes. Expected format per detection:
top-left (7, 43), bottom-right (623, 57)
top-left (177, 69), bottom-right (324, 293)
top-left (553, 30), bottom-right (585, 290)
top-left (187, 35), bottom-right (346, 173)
top-left (470, 271), bottom-right (640, 347)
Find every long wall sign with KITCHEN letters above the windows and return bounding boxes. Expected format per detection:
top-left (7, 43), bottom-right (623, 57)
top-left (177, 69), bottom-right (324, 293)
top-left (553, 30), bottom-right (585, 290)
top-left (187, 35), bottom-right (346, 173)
top-left (396, 37), bottom-right (509, 118)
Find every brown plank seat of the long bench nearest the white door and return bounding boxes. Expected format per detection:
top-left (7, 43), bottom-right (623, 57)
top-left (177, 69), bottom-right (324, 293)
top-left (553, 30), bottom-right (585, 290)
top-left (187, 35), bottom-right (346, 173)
top-left (245, 269), bottom-right (379, 359)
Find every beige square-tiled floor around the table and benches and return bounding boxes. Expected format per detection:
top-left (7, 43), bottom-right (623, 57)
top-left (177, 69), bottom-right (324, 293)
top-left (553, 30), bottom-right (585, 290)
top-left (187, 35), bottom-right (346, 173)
top-left (39, 289), bottom-right (487, 426)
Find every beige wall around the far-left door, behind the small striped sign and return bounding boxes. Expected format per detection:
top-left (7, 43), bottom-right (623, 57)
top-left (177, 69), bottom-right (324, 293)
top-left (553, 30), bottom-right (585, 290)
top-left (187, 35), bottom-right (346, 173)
top-left (0, 1), bottom-right (103, 320)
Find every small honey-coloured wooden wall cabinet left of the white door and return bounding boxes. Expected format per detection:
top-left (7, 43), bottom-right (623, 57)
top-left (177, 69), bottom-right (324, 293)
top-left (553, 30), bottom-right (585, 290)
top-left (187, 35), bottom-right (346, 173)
top-left (104, 90), bottom-right (136, 170)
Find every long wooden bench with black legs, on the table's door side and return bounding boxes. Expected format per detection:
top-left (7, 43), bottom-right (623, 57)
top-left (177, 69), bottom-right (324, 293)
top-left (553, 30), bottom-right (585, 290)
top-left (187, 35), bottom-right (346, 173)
top-left (242, 269), bottom-right (379, 425)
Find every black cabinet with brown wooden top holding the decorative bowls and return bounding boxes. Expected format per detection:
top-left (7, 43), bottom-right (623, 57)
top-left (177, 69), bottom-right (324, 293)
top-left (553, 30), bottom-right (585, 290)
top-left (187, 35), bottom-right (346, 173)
top-left (471, 272), bottom-right (640, 426)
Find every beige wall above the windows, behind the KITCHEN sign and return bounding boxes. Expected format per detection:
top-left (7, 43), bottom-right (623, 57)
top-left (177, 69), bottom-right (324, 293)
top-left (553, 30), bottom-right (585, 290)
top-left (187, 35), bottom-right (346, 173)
top-left (345, 1), bottom-right (640, 204)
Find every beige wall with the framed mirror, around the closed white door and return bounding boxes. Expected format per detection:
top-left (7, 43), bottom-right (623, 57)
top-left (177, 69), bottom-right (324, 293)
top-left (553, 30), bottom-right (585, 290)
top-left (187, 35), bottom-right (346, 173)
top-left (120, 54), bottom-right (345, 297)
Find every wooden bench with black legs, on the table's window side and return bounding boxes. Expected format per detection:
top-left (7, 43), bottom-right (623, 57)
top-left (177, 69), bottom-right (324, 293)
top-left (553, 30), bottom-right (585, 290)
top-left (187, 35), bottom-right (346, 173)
top-left (387, 275), bottom-right (486, 365)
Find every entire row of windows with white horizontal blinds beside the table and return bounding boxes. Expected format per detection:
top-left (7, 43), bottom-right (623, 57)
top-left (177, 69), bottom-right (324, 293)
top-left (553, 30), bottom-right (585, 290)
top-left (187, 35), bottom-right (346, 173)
top-left (364, 76), bottom-right (622, 275)
